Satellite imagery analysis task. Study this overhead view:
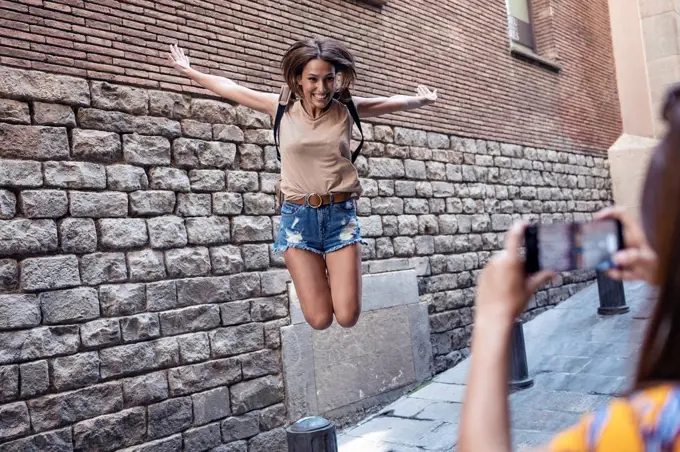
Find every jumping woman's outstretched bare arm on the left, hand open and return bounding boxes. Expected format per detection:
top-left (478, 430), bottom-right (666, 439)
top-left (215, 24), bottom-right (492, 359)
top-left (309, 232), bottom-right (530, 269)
top-left (168, 44), bottom-right (278, 115)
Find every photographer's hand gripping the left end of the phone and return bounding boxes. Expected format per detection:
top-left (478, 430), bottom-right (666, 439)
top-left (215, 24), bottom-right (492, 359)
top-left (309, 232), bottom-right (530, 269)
top-left (475, 223), bottom-right (555, 321)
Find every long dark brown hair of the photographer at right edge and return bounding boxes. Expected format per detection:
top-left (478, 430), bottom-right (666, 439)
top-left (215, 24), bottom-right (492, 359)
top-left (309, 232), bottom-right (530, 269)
top-left (634, 88), bottom-right (680, 389)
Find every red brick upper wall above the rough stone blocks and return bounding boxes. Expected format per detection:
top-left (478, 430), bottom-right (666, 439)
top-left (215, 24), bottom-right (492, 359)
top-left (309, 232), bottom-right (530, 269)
top-left (0, 0), bottom-right (620, 151)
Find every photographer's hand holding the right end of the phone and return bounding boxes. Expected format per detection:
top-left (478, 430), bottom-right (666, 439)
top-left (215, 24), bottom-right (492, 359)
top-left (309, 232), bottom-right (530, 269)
top-left (594, 207), bottom-right (658, 285)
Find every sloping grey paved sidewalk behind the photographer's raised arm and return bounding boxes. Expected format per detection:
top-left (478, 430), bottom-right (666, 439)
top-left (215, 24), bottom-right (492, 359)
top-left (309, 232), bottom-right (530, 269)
top-left (338, 283), bottom-right (649, 452)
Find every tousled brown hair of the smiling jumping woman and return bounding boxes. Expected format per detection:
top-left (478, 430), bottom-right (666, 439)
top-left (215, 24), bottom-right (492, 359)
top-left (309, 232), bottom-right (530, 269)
top-left (281, 38), bottom-right (357, 103)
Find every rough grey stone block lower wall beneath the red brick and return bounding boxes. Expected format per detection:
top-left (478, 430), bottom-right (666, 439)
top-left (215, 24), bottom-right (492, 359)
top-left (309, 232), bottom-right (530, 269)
top-left (0, 67), bottom-right (611, 452)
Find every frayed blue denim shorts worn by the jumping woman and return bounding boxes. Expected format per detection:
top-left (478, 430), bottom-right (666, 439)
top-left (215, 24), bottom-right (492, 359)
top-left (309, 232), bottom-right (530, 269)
top-left (274, 199), bottom-right (361, 254)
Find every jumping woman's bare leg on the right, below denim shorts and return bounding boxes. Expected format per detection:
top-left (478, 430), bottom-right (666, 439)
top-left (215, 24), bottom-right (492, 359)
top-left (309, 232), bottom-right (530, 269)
top-left (326, 243), bottom-right (361, 328)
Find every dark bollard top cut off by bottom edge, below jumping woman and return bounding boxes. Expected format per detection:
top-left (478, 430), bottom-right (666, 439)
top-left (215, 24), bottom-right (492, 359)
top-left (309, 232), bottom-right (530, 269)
top-left (286, 416), bottom-right (338, 452)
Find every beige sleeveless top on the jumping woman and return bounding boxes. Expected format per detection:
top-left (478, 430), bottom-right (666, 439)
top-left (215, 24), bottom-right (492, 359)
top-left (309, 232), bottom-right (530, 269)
top-left (279, 99), bottom-right (361, 200)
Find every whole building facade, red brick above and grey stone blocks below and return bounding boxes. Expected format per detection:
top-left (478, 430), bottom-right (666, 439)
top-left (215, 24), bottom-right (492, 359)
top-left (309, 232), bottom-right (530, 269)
top-left (0, 0), bottom-right (625, 452)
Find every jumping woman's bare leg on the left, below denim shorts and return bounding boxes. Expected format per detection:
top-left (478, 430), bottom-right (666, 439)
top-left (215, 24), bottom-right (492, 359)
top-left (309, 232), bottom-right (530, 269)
top-left (283, 248), bottom-right (333, 330)
